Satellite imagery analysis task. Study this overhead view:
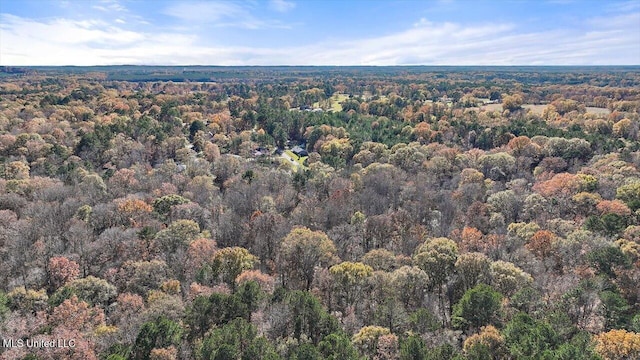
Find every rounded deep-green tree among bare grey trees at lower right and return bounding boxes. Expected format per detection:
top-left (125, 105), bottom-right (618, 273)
top-left (453, 284), bottom-right (502, 330)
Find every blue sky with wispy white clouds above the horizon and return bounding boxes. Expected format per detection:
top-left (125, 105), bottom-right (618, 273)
top-left (0, 0), bottom-right (640, 66)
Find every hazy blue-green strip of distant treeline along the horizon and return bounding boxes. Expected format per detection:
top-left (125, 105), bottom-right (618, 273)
top-left (5, 65), bottom-right (640, 84)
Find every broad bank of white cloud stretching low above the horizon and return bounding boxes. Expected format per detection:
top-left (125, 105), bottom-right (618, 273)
top-left (0, 8), bottom-right (640, 65)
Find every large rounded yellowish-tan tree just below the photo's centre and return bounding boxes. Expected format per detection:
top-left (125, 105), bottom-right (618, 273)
top-left (279, 227), bottom-right (336, 290)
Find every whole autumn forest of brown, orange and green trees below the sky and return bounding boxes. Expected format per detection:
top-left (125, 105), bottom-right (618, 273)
top-left (0, 66), bottom-right (640, 360)
